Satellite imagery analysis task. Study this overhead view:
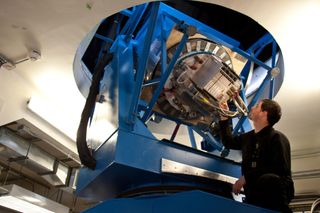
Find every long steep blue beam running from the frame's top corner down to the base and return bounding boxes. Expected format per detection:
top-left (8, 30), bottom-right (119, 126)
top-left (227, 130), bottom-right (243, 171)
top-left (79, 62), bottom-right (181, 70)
top-left (128, 2), bottom-right (160, 124)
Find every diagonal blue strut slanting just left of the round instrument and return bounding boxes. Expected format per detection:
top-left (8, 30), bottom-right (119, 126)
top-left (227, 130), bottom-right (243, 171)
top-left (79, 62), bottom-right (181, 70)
top-left (142, 29), bottom-right (189, 122)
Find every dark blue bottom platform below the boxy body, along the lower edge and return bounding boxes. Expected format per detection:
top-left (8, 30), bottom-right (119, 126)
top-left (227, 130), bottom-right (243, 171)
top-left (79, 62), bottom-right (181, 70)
top-left (84, 190), bottom-right (273, 213)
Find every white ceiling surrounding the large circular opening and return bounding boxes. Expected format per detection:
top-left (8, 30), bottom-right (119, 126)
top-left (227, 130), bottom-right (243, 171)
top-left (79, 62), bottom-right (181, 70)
top-left (0, 0), bottom-right (320, 196)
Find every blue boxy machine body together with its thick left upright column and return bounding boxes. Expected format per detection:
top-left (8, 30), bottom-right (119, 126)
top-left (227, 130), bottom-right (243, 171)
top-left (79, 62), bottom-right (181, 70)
top-left (77, 5), bottom-right (240, 200)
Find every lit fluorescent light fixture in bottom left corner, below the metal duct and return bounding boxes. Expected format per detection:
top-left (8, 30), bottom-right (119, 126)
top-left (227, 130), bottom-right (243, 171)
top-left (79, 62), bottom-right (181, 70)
top-left (0, 184), bottom-right (69, 213)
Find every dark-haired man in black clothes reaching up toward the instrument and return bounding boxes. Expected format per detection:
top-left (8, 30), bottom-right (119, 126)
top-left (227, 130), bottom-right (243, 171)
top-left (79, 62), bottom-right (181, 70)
top-left (220, 99), bottom-right (294, 212)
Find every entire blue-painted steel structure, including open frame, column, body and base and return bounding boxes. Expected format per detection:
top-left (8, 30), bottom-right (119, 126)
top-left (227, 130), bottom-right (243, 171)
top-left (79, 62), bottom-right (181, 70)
top-left (77, 2), bottom-right (284, 213)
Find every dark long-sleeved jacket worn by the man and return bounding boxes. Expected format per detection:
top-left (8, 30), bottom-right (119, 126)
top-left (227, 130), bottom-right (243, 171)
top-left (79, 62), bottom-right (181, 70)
top-left (220, 121), bottom-right (294, 201)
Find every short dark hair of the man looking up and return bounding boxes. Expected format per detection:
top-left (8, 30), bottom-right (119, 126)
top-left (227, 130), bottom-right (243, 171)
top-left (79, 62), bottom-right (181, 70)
top-left (261, 99), bottom-right (282, 126)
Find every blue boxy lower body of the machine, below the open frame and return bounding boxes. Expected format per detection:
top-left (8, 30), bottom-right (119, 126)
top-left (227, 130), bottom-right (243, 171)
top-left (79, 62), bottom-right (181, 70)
top-left (77, 121), bottom-right (240, 200)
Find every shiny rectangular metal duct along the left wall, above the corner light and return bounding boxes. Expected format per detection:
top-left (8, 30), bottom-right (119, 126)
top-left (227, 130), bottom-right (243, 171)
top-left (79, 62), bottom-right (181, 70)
top-left (0, 128), bottom-right (69, 186)
